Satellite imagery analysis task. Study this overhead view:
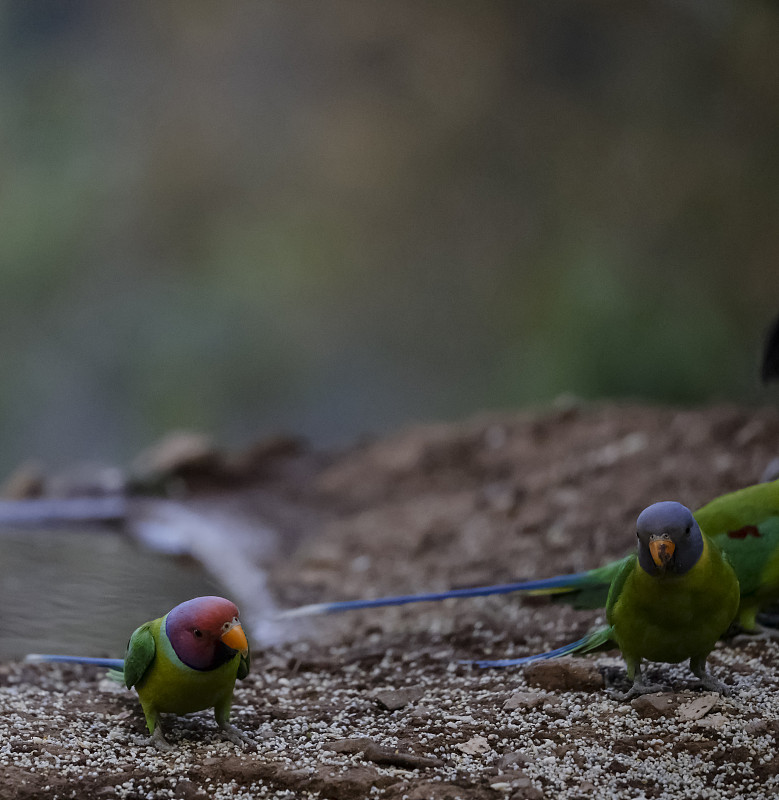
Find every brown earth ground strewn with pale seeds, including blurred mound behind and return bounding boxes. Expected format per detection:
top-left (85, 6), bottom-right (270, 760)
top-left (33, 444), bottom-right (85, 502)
top-left (0, 407), bottom-right (779, 800)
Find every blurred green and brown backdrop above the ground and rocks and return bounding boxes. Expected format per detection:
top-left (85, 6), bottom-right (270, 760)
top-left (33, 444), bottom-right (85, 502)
top-left (0, 0), bottom-right (779, 471)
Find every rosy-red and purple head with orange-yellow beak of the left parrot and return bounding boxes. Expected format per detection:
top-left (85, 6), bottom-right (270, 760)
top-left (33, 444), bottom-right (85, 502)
top-left (165, 597), bottom-right (249, 670)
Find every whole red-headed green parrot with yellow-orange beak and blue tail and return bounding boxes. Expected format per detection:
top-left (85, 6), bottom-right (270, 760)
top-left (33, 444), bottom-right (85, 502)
top-left (27, 596), bottom-right (250, 750)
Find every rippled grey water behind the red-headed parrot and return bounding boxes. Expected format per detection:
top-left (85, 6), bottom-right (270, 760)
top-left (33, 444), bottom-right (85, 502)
top-left (0, 527), bottom-right (219, 660)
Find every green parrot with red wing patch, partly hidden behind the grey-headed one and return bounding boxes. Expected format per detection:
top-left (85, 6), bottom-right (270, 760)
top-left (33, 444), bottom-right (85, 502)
top-left (281, 480), bottom-right (779, 632)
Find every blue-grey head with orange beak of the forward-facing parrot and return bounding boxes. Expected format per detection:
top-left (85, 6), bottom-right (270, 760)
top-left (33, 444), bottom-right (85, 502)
top-left (636, 501), bottom-right (703, 575)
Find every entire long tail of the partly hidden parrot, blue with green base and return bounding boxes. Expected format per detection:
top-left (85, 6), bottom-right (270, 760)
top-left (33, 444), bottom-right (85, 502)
top-left (277, 561), bottom-right (622, 619)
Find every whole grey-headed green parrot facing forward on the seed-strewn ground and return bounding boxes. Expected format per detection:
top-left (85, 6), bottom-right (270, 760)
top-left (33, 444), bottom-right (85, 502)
top-left (466, 501), bottom-right (739, 697)
